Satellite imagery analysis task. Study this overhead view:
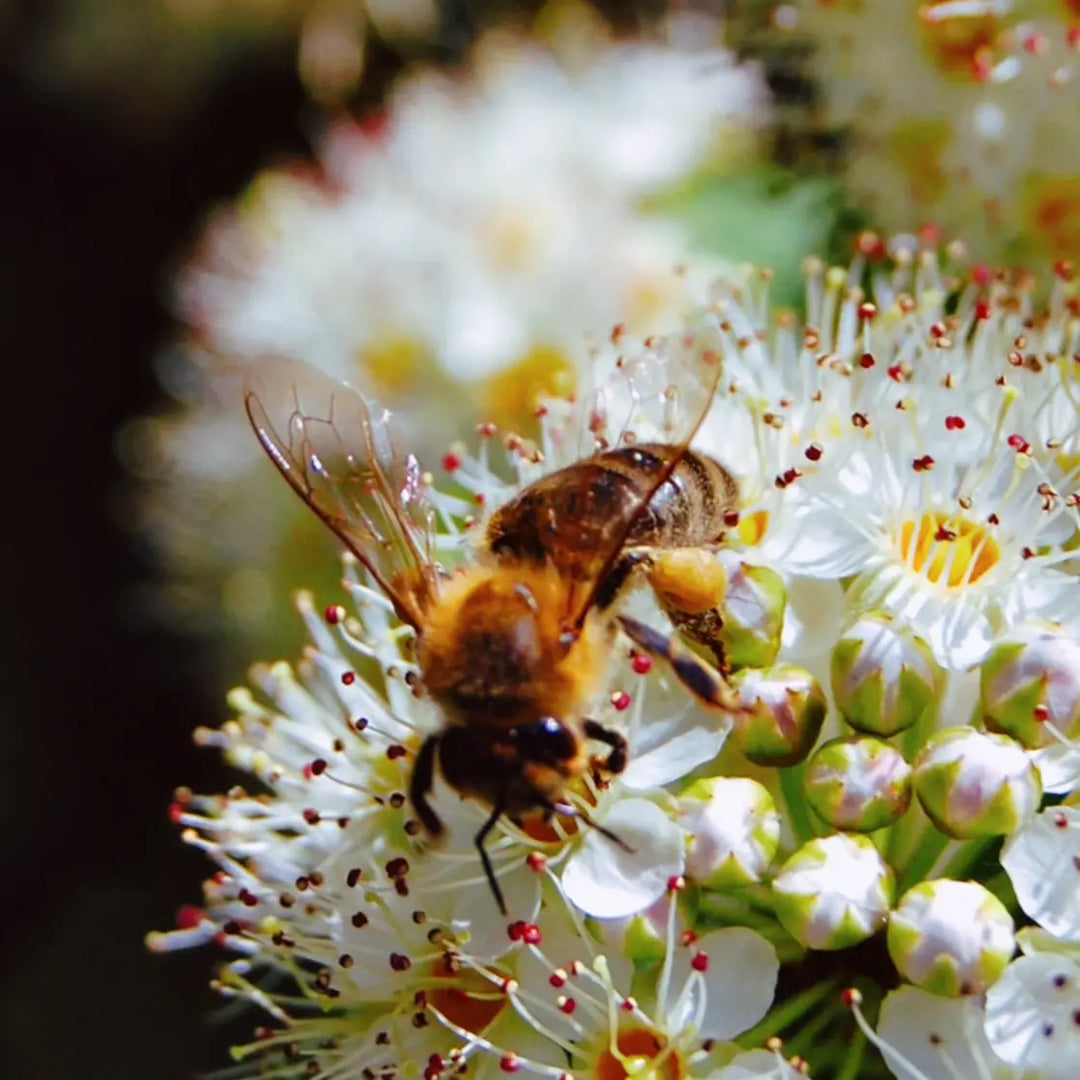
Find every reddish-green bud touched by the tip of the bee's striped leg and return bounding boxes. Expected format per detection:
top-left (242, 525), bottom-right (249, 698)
top-left (731, 664), bottom-right (828, 766)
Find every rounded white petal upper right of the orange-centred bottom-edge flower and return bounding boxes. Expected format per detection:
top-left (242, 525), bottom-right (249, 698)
top-left (664, 927), bottom-right (780, 1039)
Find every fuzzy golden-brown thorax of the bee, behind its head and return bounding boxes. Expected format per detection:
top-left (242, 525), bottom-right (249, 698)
top-left (417, 564), bottom-right (613, 728)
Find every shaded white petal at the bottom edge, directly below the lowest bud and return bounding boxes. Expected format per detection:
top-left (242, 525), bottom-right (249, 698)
top-left (877, 986), bottom-right (1020, 1080)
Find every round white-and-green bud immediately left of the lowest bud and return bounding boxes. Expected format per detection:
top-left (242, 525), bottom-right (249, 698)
top-left (772, 833), bottom-right (895, 949)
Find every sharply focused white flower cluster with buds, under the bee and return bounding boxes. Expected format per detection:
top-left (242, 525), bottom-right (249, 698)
top-left (151, 235), bottom-right (1080, 1080)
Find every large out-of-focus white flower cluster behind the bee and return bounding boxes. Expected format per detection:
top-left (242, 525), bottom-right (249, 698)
top-left (121, 22), bottom-right (766, 648)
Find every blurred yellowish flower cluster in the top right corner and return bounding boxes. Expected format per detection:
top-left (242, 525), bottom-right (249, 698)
top-left (773, 0), bottom-right (1080, 259)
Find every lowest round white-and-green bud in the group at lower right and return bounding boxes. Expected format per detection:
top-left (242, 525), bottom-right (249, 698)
top-left (887, 878), bottom-right (1016, 997)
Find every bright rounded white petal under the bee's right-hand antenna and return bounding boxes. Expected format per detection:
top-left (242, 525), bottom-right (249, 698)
top-left (563, 799), bottom-right (684, 919)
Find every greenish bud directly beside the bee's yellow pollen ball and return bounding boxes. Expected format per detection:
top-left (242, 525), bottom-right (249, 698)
top-left (717, 551), bottom-right (787, 669)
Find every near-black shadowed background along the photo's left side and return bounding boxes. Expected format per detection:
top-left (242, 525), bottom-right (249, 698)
top-left (0, 0), bottom-right (691, 1080)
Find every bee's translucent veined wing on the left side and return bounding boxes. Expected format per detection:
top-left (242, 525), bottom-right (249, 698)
top-left (244, 360), bottom-right (438, 626)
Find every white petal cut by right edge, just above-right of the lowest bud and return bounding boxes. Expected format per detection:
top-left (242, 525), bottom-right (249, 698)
top-left (1001, 806), bottom-right (1080, 942)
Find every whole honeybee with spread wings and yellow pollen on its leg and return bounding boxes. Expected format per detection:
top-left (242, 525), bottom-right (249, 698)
top-left (245, 349), bottom-right (739, 914)
